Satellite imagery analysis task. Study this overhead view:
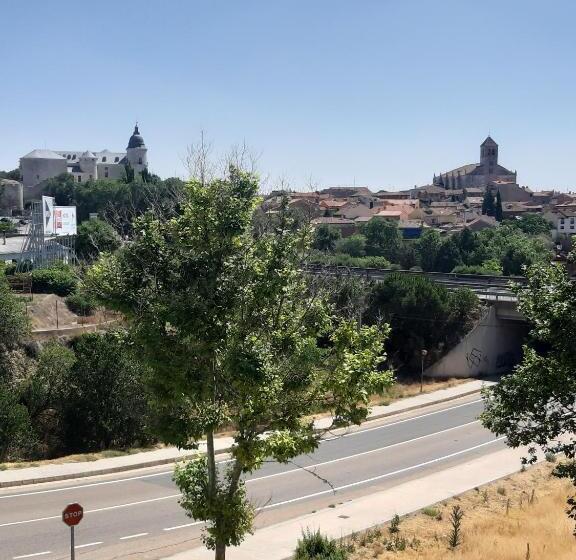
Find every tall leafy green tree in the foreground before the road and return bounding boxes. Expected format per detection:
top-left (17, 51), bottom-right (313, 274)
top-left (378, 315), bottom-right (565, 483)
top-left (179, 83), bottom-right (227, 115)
top-left (87, 167), bottom-right (392, 560)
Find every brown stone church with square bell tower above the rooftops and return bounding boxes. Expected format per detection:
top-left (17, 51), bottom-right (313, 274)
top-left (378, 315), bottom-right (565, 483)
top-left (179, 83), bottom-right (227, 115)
top-left (433, 136), bottom-right (516, 189)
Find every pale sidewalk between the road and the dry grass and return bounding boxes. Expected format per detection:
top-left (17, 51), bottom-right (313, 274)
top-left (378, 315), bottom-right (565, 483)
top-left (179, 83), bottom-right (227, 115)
top-left (165, 449), bottom-right (526, 560)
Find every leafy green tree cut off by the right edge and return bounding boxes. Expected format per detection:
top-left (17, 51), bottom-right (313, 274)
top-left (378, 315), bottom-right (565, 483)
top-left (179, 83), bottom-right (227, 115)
top-left (482, 258), bottom-right (576, 519)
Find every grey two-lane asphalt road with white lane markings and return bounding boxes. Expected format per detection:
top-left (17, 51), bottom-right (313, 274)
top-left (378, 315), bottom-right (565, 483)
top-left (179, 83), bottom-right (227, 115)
top-left (0, 396), bottom-right (504, 560)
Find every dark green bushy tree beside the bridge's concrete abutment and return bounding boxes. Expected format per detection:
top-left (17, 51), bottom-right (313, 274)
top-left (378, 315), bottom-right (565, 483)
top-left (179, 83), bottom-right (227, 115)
top-left (366, 273), bottom-right (480, 371)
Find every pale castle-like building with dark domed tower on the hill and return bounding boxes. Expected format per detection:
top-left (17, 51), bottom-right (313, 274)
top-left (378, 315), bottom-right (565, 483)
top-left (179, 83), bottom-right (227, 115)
top-left (20, 124), bottom-right (148, 188)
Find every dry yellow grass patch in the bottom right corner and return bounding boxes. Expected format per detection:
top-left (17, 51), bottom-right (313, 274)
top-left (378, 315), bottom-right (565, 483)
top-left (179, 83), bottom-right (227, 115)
top-left (350, 463), bottom-right (576, 560)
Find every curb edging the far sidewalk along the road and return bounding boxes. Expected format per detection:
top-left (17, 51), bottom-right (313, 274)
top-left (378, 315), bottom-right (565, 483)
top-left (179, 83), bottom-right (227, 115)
top-left (0, 388), bottom-right (482, 488)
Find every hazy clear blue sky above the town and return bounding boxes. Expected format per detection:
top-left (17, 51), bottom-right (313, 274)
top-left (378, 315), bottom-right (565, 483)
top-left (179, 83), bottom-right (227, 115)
top-left (0, 0), bottom-right (576, 188)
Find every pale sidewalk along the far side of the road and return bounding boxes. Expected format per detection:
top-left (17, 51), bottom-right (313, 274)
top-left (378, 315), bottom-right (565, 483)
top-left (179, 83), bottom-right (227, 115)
top-left (0, 380), bottom-right (492, 488)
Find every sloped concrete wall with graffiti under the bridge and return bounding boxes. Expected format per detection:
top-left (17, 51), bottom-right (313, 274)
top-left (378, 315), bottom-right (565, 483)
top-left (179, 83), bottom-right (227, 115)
top-left (424, 306), bottom-right (527, 377)
